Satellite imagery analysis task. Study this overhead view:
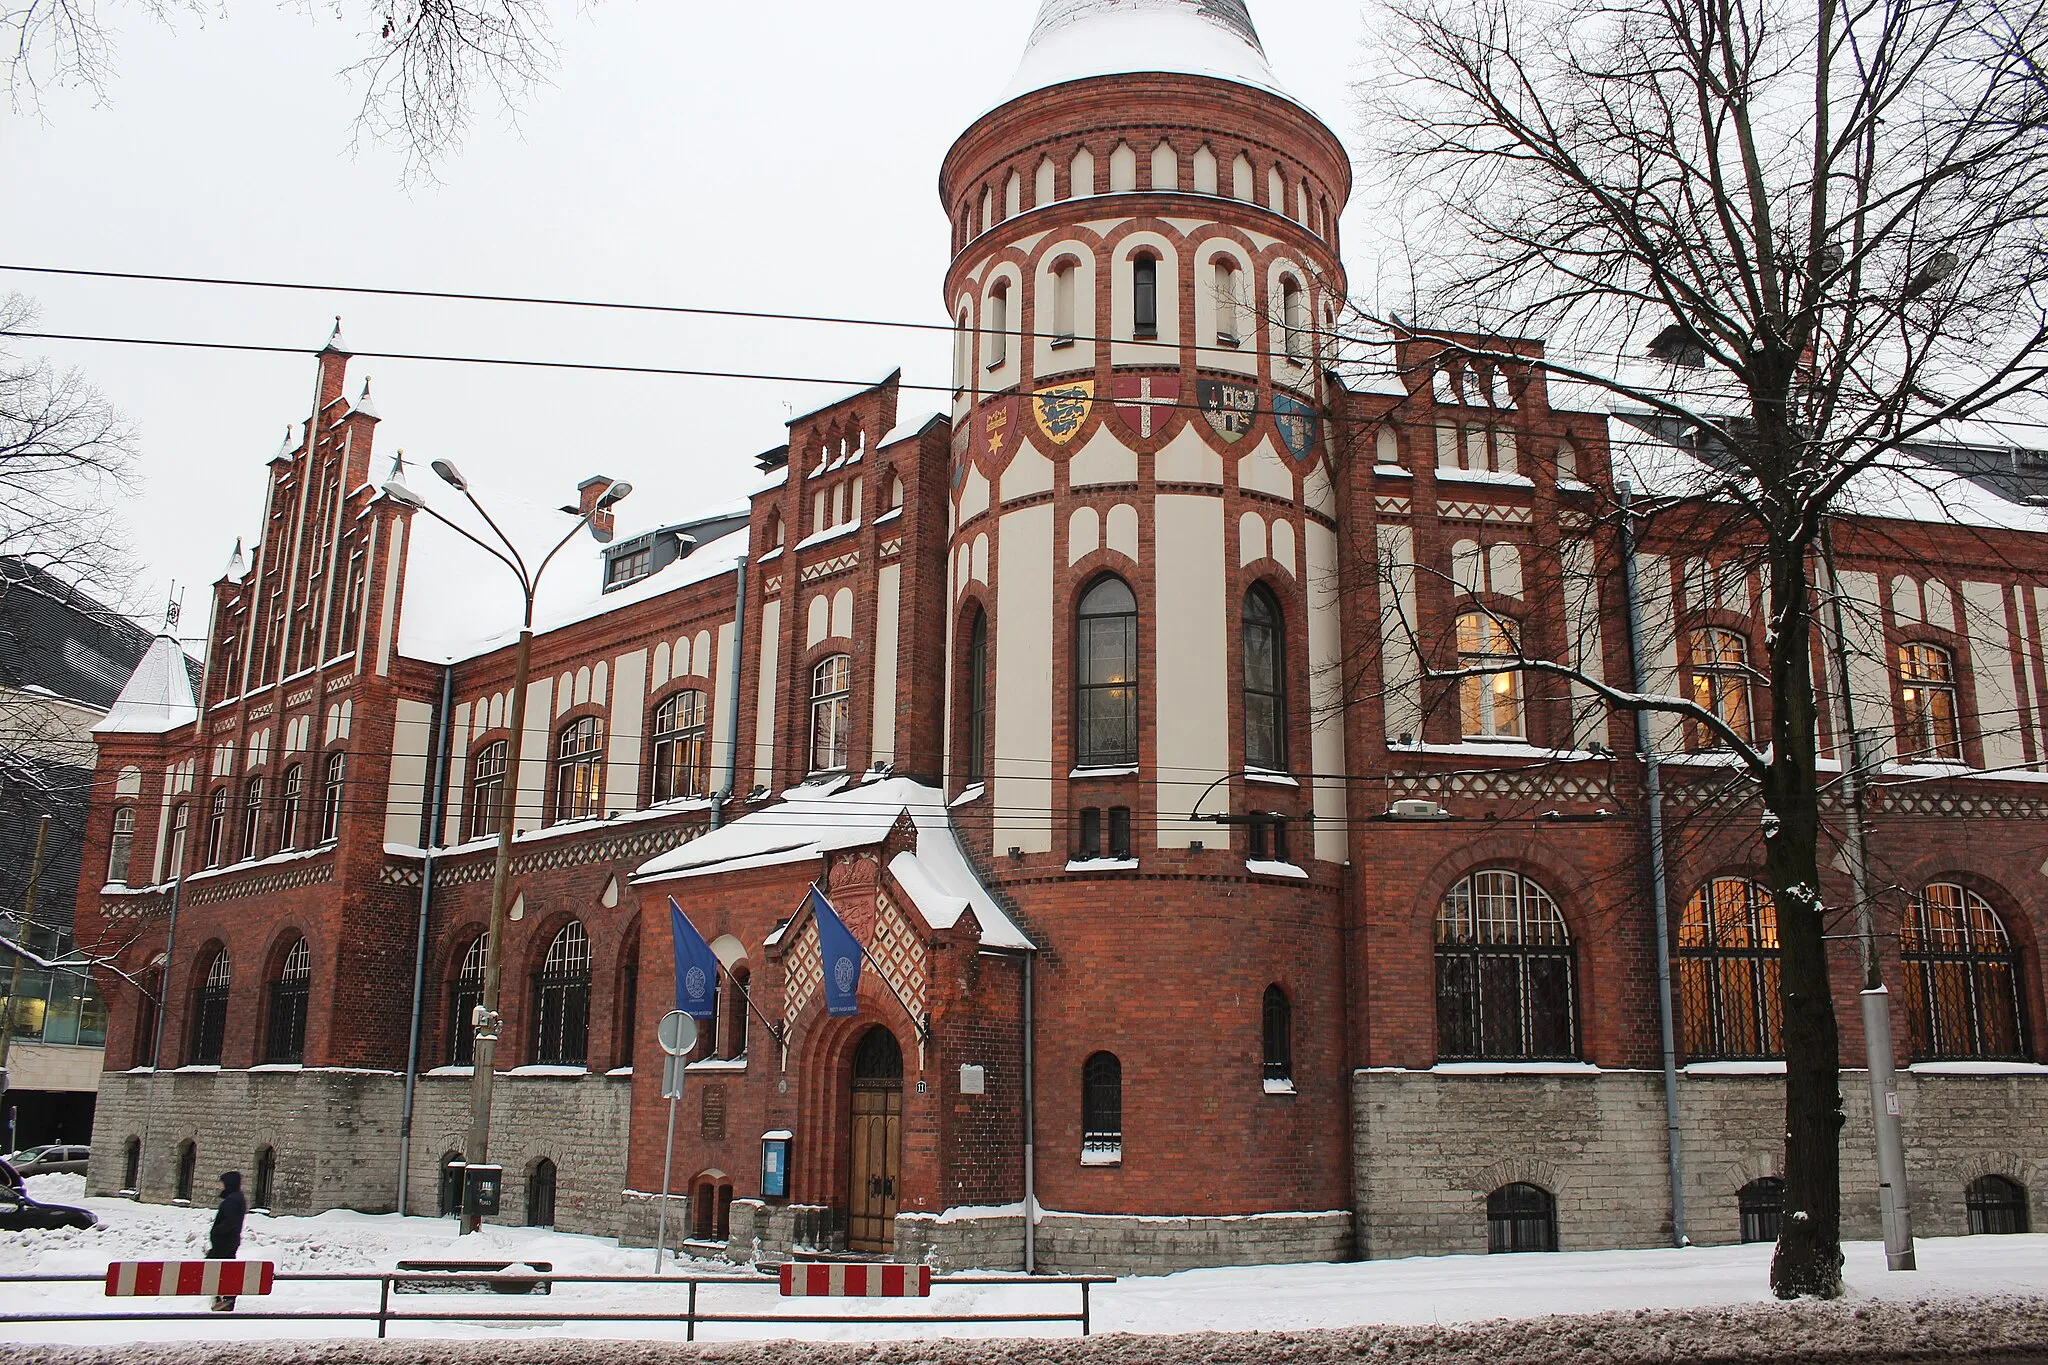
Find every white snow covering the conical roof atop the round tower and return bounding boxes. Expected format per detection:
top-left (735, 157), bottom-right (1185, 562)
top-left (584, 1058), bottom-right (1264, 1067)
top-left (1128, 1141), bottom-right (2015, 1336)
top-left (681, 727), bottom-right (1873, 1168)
top-left (997, 0), bottom-right (1294, 104)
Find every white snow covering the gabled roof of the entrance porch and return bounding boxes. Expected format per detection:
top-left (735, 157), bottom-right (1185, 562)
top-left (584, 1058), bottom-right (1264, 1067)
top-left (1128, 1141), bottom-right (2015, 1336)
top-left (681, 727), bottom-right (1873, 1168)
top-left (633, 778), bottom-right (1032, 948)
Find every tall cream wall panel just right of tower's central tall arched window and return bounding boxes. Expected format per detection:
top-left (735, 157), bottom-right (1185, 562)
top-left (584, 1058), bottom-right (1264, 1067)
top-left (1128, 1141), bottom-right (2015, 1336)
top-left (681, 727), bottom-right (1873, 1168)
top-left (1149, 493), bottom-right (1235, 849)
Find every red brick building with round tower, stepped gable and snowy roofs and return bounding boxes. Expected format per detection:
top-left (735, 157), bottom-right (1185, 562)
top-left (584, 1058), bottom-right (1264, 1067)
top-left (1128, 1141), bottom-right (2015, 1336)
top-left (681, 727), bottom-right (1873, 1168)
top-left (80, 0), bottom-right (2048, 1269)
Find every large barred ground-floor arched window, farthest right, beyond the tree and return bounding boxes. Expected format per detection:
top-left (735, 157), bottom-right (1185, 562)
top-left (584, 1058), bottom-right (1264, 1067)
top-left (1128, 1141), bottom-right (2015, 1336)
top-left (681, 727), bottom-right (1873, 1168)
top-left (1898, 884), bottom-right (2028, 1062)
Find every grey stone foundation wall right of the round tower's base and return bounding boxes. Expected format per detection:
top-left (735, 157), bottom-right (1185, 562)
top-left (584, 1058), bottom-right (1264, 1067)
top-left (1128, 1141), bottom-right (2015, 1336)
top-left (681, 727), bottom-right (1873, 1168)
top-left (1354, 1070), bottom-right (2048, 1259)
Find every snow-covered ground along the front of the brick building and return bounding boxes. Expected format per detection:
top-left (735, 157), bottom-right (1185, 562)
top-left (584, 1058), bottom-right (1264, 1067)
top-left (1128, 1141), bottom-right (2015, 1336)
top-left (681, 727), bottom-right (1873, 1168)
top-left (0, 1175), bottom-right (2048, 1342)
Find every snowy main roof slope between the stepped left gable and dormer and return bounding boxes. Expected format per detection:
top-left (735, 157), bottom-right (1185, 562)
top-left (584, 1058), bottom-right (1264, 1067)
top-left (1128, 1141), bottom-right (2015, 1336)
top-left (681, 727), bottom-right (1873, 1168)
top-left (397, 479), bottom-right (748, 663)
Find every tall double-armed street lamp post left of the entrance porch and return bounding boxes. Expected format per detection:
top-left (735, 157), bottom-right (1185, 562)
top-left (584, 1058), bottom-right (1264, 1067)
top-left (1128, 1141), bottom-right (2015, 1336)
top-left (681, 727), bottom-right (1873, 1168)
top-left (383, 460), bottom-right (633, 1232)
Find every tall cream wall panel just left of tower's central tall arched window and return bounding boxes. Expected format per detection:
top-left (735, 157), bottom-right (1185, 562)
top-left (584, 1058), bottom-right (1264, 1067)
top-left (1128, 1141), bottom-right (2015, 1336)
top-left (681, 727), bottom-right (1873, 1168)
top-left (991, 503), bottom-right (1053, 853)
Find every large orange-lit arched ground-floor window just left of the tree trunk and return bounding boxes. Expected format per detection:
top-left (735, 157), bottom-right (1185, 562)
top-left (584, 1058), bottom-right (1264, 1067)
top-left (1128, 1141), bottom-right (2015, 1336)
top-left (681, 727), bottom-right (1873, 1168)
top-left (1677, 876), bottom-right (1786, 1062)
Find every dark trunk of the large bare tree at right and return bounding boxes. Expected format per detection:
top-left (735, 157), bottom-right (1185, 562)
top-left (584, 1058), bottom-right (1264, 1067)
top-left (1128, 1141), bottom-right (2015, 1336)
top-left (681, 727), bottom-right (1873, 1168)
top-left (1763, 536), bottom-right (1843, 1300)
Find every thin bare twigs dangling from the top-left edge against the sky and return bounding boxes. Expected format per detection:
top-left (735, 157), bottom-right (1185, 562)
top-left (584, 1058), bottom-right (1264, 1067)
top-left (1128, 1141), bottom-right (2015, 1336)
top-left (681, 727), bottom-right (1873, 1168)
top-left (0, 0), bottom-right (555, 174)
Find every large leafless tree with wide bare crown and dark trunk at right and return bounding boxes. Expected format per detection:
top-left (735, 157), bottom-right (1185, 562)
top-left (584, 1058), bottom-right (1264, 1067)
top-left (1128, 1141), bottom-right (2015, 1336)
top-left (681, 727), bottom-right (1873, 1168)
top-left (1362, 0), bottom-right (2048, 1297)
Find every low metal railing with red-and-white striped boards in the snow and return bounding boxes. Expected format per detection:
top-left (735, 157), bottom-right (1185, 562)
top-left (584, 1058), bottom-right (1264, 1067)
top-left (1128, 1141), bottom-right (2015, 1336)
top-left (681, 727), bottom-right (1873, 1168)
top-left (0, 1267), bottom-right (1116, 1340)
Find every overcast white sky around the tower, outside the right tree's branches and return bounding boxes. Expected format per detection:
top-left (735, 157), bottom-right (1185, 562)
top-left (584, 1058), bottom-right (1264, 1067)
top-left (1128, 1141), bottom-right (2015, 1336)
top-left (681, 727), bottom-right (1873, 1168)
top-left (0, 0), bottom-right (1372, 636)
